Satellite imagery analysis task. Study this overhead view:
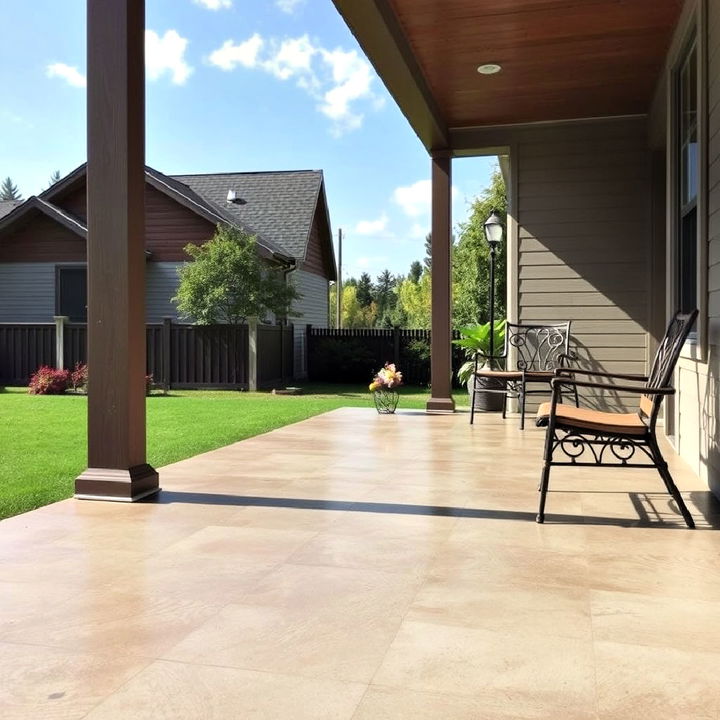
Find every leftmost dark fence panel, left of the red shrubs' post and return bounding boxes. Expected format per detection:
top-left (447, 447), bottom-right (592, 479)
top-left (0, 323), bottom-right (55, 385)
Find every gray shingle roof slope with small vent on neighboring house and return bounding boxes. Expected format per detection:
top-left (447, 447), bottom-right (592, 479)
top-left (172, 170), bottom-right (323, 259)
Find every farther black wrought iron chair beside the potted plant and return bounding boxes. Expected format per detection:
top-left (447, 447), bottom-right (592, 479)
top-left (470, 322), bottom-right (578, 430)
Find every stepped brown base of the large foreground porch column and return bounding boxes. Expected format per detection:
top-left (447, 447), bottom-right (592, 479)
top-left (75, 464), bottom-right (160, 502)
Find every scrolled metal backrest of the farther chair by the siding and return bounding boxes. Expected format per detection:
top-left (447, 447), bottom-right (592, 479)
top-left (505, 322), bottom-right (570, 371)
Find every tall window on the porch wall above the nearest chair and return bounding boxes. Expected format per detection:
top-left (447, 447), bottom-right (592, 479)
top-left (676, 39), bottom-right (699, 312)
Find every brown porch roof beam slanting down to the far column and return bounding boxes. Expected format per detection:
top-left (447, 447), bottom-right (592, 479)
top-left (333, 0), bottom-right (449, 152)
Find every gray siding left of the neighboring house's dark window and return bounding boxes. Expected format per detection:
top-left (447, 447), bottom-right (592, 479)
top-left (0, 263), bottom-right (55, 323)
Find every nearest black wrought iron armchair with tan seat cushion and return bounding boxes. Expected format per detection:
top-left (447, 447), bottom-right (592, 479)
top-left (536, 310), bottom-right (697, 528)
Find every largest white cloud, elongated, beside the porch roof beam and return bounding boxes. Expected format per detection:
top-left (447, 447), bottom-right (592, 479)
top-left (208, 33), bottom-right (384, 137)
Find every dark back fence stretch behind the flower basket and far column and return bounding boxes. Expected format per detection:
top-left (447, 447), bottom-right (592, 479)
top-left (307, 326), bottom-right (465, 386)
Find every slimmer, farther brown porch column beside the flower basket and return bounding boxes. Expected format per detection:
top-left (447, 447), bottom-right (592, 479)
top-left (427, 153), bottom-right (455, 412)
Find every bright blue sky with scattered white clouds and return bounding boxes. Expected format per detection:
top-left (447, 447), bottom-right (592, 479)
top-left (0, 0), bottom-right (495, 277)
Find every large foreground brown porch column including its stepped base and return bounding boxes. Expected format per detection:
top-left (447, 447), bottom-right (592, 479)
top-left (75, 0), bottom-right (159, 501)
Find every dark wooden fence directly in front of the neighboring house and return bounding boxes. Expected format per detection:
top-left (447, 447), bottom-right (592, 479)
top-left (0, 320), bottom-right (293, 389)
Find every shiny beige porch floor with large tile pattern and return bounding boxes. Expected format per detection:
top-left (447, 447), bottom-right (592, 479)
top-left (0, 409), bottom-right (720, 720)
